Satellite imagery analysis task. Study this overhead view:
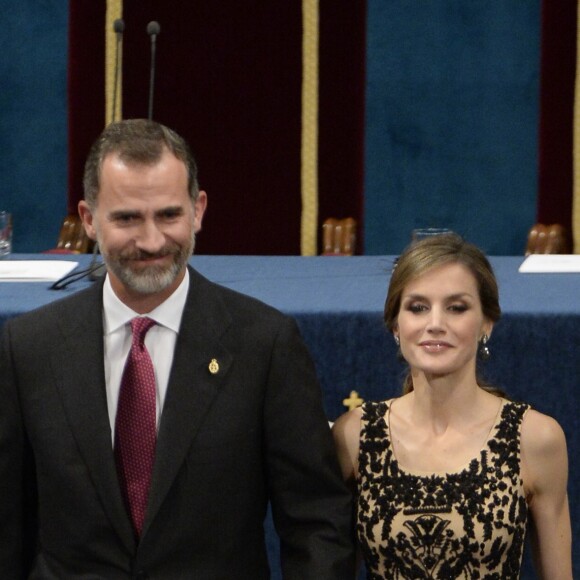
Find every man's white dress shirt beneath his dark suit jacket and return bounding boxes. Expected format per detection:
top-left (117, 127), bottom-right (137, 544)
top-left (103, 270), bottom-right (189, 444)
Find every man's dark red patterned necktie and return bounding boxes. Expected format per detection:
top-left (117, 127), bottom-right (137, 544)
top-left (115, 317), bottom-right (157, 537)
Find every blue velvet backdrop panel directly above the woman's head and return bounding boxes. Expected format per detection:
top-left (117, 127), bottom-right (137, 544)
top-left (365, 0), bottom-right (541, 255)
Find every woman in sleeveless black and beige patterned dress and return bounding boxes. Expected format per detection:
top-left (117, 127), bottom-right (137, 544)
top-left (333, 234), bottom-right (572, 580)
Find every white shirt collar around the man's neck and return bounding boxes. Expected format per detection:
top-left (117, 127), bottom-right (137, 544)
top-left (103, 268), bottom-right (189, 335)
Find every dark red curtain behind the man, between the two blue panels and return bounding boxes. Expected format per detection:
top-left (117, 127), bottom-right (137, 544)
top-left (69, 0), bottom-right (366, 255)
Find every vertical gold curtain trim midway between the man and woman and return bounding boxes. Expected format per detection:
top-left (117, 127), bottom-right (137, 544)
top-left (300, 0), bottom-right (319, 256)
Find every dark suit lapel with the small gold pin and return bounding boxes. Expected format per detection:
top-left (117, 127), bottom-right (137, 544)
top-left (143, 269), bottom-right (232, 534)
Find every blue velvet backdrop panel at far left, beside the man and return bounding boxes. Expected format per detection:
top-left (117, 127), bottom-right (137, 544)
top-left (0, 0), bottom-right (68, 252)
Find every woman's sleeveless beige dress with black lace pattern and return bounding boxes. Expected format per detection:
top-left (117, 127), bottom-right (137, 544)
top-left (356, 400), bottom-right (529, 580)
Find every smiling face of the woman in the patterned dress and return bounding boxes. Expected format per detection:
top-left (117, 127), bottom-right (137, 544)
top-left (394, 263), bottom-right (493, 377)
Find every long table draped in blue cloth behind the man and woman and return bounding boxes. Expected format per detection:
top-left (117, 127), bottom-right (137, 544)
top-left (0, 255), bottom-right (580, 578)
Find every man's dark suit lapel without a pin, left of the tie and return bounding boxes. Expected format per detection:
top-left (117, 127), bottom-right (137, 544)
top-left (52, 284), bottom-right (135, 551)
